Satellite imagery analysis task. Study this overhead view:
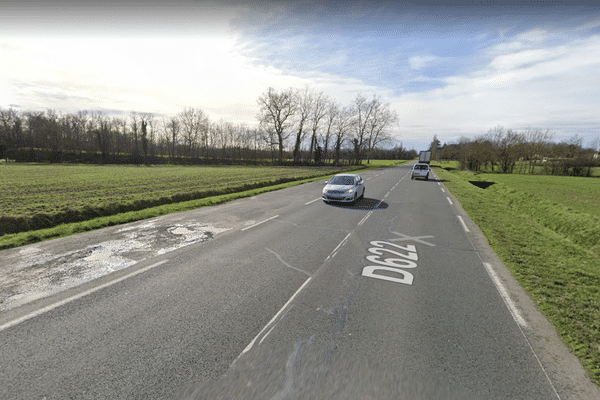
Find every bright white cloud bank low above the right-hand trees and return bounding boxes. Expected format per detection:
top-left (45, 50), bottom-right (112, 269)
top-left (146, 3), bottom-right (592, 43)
top-left (394, 31), bottom-right (600, 147)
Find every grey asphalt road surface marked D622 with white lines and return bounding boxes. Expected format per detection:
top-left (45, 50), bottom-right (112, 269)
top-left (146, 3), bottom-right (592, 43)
top-left (0, 162), bottom-right (600, 400)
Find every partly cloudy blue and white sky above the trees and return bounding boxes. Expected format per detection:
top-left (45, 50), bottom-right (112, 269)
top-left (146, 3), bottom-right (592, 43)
top-left (0, 0), bottom-right (600, 150)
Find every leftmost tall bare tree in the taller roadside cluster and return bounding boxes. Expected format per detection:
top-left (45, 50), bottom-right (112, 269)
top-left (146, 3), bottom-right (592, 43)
top-left (258, 87), bottom-right (296, 163)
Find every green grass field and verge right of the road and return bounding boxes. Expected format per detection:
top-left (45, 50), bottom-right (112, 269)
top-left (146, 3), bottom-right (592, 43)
top-left (434, 163), bottom-right (600, 385)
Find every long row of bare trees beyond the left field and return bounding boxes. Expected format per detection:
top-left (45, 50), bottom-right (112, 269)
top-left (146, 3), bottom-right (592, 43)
top-left (0, 87), bottom-right (403, 164)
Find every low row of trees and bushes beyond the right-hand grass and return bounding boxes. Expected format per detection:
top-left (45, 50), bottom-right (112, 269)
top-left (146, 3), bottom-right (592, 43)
top-left (430, 126), bottom-right (600, 176)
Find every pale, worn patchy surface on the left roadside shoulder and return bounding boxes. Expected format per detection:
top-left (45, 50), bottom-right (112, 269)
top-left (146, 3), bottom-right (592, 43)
top-left (0, 221), bottom-right (228, 312)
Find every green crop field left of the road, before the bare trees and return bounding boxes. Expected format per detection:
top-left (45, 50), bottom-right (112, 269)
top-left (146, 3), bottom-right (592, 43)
top-left (0, 164), bottom-right (356, 248)
